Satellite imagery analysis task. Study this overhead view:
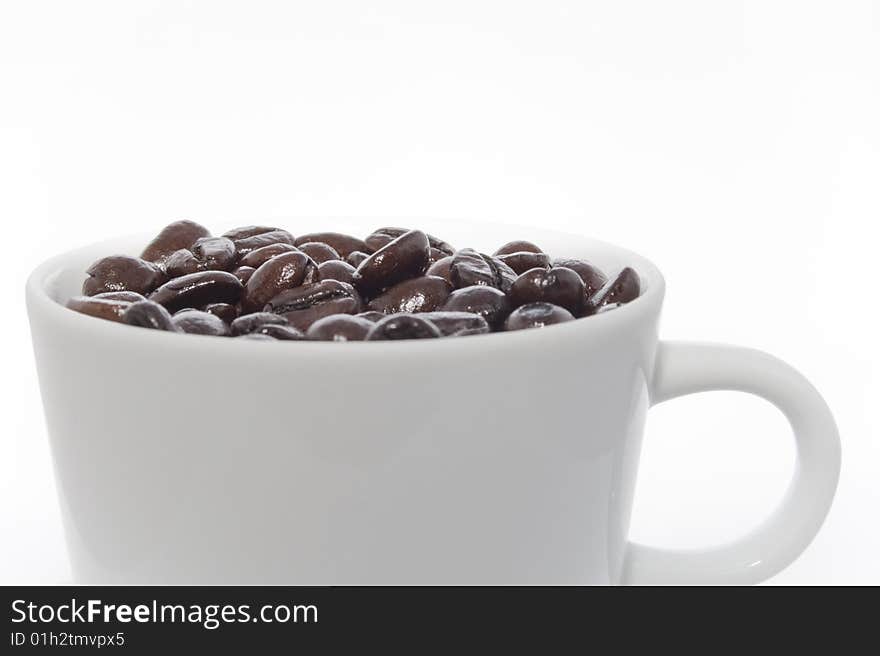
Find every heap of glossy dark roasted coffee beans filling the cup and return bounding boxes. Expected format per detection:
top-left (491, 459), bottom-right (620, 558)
top-left (67, 221), bottom-right (639, 341)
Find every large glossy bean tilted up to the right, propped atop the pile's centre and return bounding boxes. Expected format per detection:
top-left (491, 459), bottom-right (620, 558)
top-left (353, 230), bottom-right (430, 296)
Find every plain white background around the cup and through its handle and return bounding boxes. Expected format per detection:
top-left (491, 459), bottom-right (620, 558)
top-left (0, 0), bottom-right (880, 584)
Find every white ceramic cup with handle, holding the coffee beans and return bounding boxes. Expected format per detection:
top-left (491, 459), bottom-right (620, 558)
top-left (27, 219), bottom-right (840, 585)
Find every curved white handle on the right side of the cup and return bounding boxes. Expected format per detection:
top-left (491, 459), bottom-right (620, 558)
top-left (622, 342), bottom-right (840, 585)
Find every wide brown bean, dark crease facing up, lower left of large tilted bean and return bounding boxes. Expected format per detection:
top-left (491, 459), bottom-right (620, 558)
top-left (264, 280), bottom-right (361, 331)
